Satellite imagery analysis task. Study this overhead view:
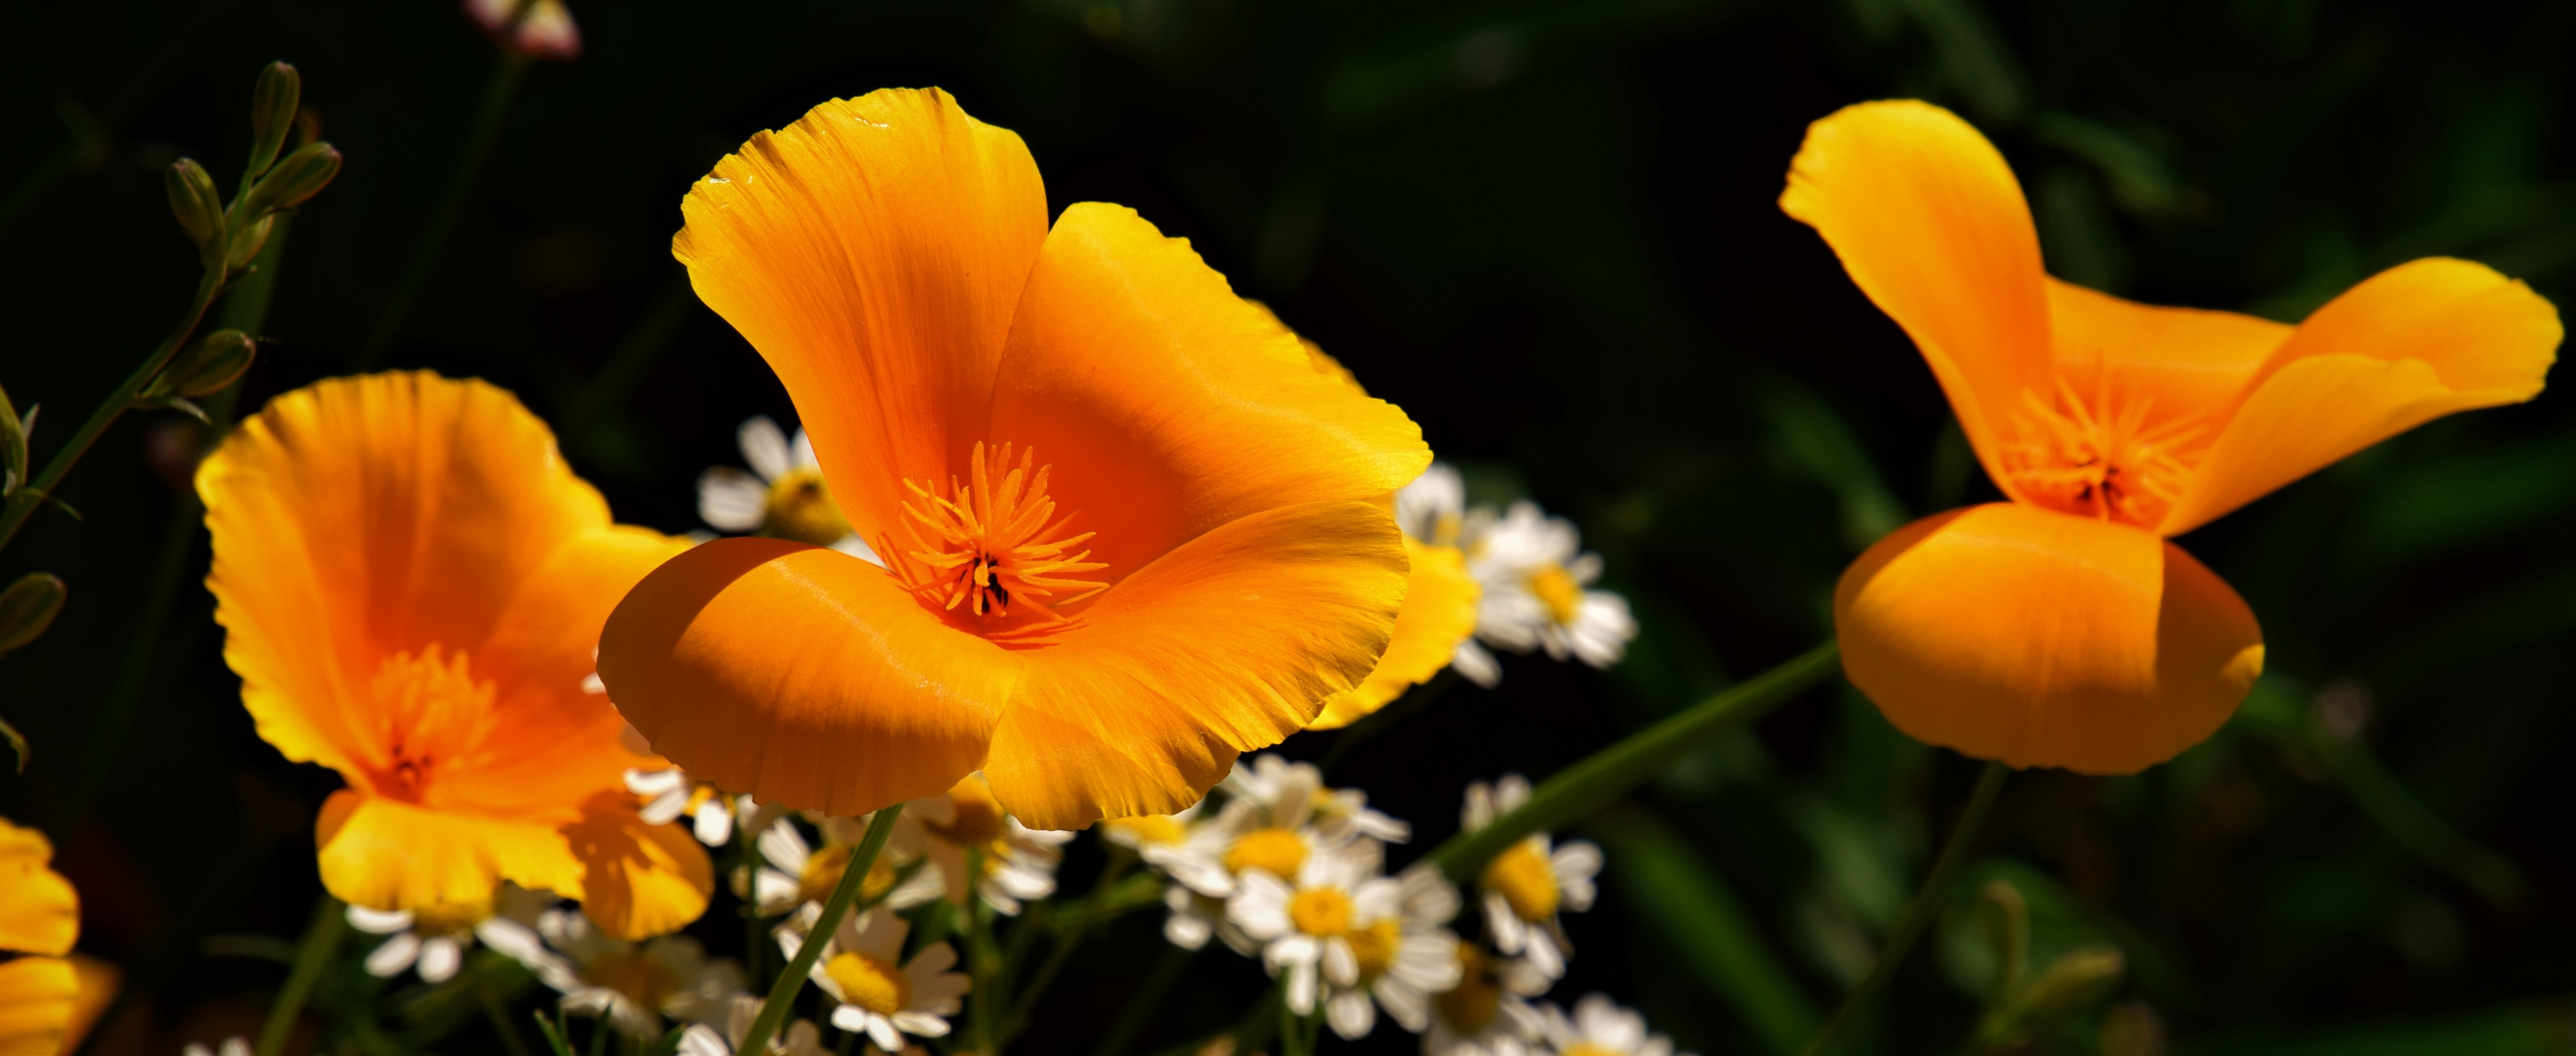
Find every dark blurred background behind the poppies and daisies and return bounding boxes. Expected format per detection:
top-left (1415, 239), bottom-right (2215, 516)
top-left (0, 0), bottom-right (2576, 1053)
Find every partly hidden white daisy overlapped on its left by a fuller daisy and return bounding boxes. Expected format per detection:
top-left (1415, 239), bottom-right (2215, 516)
top-left (1324, 865), bottom-right (1461, 1040)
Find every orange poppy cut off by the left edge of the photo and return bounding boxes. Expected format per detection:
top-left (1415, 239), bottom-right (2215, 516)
top-left (0, 819), bottom-right (80, 1056)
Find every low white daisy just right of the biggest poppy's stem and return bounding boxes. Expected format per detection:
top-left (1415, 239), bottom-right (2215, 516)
top-left (778, 906), bottom-right (969, 1053)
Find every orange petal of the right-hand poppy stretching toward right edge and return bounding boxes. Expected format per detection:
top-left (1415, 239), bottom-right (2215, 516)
top-left (2159, 257), bottom-right (2565, 536)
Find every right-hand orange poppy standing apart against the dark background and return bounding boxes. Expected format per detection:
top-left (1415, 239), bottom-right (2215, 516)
top-left (1780, 101), bottom-right (2560, 772)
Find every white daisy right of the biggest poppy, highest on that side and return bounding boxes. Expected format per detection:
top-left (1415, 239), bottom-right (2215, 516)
top-left (1465, 503), bottom-right (1636, 667)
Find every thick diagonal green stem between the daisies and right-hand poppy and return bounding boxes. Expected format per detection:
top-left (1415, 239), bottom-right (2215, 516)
top-left (1422, 641), bottom-right (1839, 884)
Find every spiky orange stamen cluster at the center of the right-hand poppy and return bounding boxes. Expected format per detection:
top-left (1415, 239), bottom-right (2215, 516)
top-left (2001, 378), bottom-right (2200, 528)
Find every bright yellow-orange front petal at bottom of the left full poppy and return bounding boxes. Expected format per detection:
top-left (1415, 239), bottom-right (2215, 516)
top-left (314, 788), bottom-right (583, 909)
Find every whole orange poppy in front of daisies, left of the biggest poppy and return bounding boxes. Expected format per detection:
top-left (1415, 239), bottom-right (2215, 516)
top-left (196, 374), bottom-right (711, 938)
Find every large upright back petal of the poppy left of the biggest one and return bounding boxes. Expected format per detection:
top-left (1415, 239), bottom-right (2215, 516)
top-left (196, 371), bottom-right (608, 772)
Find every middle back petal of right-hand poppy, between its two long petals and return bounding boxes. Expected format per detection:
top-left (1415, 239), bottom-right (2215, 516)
top-left (2048, 278), bottom-right (2292, 429)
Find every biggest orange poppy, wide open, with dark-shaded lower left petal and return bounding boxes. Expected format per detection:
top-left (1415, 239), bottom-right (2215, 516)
top-left (600, 90), bottom-right (1429, 829)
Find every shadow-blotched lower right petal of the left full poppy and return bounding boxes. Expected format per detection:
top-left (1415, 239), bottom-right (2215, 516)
top-left (561, 793), bottom-right (717, 943)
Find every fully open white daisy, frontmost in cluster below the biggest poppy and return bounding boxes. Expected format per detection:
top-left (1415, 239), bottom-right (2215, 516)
top-left (1226, 840), bottom-right (1404, 1015)
